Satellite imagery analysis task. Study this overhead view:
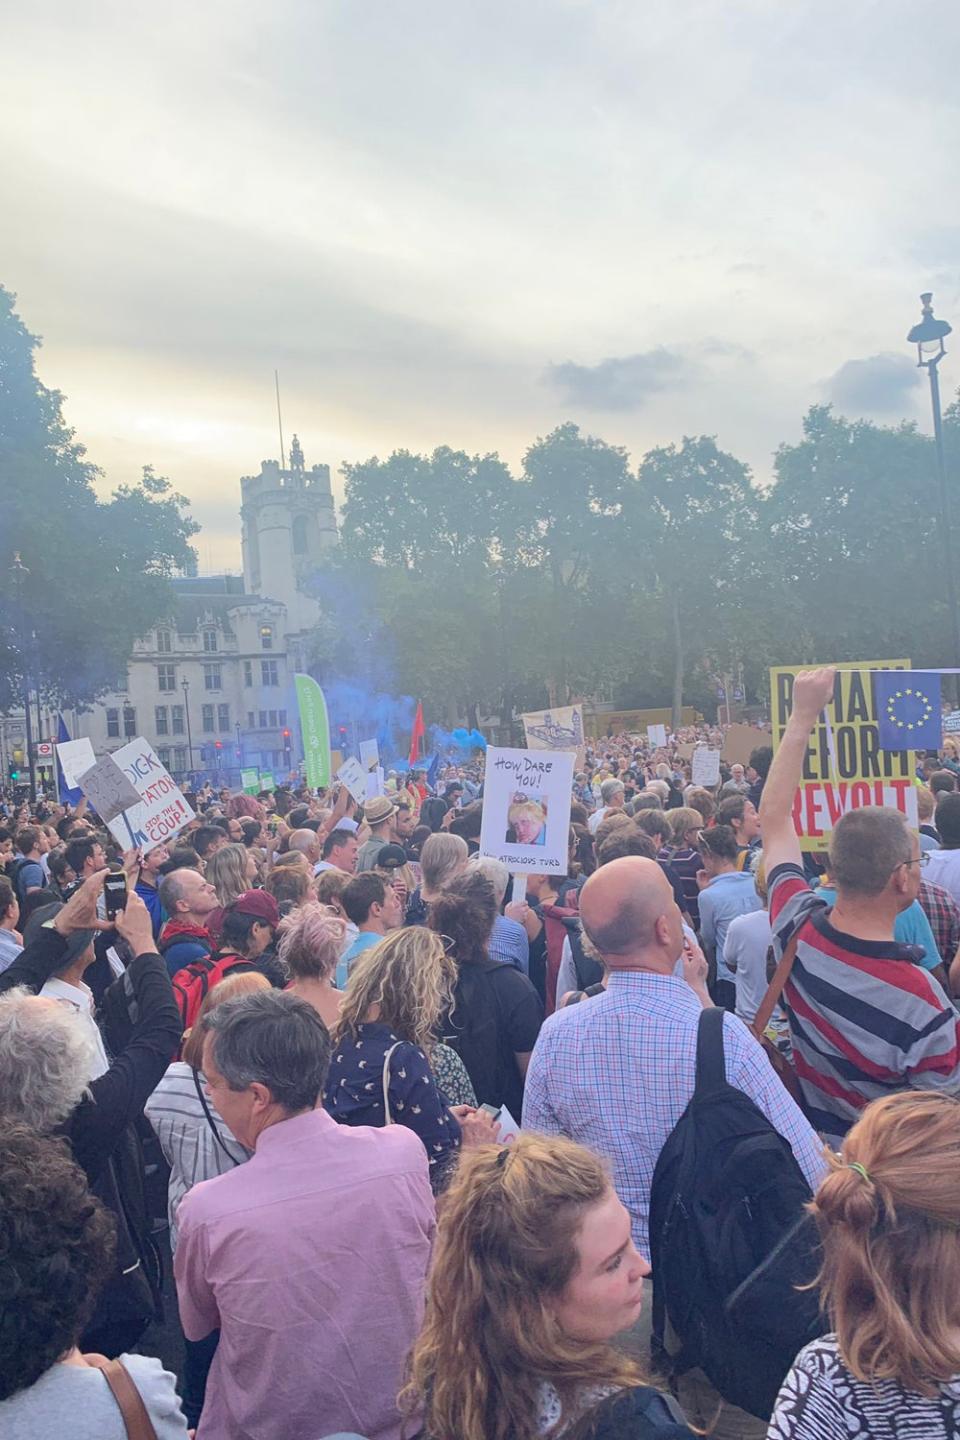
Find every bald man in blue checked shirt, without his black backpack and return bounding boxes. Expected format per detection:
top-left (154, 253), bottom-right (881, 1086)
top-left (522, 855), bottom-right (825, 1440)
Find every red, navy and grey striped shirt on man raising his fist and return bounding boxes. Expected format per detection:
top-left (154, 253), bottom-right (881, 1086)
top-left (769, 865), bottom-right (960, 1139)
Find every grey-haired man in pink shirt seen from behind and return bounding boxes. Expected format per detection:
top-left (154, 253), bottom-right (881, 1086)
top-left (174, 991), bottom-right (435, 1440)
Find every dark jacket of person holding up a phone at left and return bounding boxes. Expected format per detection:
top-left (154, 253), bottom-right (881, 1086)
top-left (0, 929), bottom-right (181, 1355)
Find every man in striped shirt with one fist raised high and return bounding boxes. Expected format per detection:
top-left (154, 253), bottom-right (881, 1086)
top-left (760, 667), bottom-right (960, 1143)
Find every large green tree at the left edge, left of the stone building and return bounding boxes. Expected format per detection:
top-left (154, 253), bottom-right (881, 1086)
top-left (0, 287), bottom-right (197, 711)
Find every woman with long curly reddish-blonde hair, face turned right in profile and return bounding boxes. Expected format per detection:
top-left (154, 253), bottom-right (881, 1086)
top-left (400, 1135), bottom-right (691, 1440)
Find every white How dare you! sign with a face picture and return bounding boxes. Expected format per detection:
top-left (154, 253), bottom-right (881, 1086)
top-left (479, 746), bottom-right (574, 876)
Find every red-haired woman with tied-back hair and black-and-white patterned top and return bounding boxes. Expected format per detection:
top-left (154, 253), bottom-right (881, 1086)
top-left (770, 1090), bottom-right (960, 1440)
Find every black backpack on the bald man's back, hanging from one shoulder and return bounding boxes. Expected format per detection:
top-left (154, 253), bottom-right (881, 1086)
top-left (651, 1008), bottom-right (826, 1420)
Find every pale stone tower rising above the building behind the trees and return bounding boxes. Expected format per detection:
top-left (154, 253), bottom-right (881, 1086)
top-left (240, 435), bottom-right (337, 634)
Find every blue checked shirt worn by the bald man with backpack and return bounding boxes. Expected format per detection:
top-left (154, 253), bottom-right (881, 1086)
top-left (522, 971), bottom-right (825, 1256)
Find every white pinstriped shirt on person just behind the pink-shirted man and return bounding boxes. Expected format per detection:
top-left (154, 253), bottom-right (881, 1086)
top-left (144, 1060), bottom-right (250, 1251)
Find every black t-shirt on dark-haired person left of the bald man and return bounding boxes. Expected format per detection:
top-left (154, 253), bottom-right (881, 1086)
top-left (443, 960), bottom-right (543, 1123)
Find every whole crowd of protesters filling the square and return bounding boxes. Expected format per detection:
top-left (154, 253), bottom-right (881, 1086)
top-left (0, 670), bottom-right (960, 1440)
